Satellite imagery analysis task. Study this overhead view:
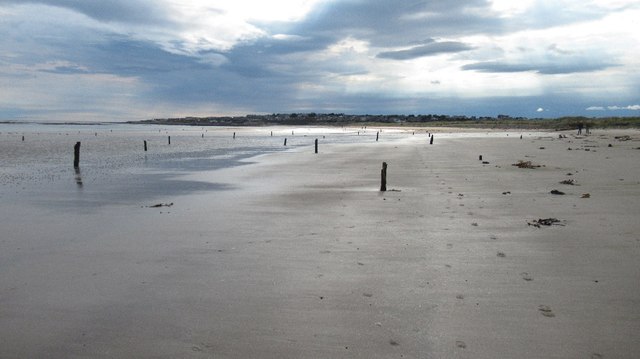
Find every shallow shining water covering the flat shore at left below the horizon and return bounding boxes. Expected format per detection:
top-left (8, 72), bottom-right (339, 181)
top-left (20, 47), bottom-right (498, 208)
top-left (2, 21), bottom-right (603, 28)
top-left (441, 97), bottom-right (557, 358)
top-left (0, 124), bottom-right (406, 211)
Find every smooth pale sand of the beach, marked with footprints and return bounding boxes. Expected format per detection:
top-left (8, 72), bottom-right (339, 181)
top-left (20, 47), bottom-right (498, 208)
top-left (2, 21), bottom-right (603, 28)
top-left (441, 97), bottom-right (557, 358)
top-left (0, 131), bottom-right (640, 358)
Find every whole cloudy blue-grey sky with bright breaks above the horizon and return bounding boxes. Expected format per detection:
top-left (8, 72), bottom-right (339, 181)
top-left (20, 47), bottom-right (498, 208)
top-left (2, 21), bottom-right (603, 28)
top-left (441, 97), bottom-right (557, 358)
top-left (0, 0), bottom-right (640, 121)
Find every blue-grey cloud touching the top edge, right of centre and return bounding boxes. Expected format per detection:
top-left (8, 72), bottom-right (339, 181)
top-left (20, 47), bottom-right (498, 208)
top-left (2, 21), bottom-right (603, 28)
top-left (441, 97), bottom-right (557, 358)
top-left (292, 0), bottom-right (503, 47)
